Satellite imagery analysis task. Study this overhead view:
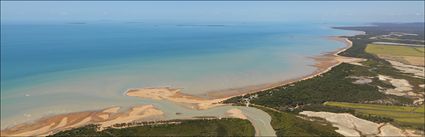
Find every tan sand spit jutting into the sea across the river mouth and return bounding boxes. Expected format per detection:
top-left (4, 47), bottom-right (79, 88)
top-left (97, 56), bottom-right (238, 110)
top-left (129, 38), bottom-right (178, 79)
top-left (126, 87), bottom-right (228, 109)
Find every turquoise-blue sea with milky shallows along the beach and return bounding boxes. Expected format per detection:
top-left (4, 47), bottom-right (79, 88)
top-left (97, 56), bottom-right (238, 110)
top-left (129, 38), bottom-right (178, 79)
top-left (1, 23), bottom-right (349, 127)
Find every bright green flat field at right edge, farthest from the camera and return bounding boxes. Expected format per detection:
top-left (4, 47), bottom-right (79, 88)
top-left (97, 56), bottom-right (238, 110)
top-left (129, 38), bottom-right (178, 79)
top-left (365, 44), bottom-right (424, 57)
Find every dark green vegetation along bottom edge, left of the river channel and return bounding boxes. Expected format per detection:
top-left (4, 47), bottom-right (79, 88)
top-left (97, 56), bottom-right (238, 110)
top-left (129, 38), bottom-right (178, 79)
top-left (52, 118), bottom-right (255, 136)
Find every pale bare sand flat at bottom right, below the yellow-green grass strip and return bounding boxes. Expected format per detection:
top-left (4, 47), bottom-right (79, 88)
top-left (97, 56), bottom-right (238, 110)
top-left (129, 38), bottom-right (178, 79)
top-left (300, 111), bottom-right (411, 136)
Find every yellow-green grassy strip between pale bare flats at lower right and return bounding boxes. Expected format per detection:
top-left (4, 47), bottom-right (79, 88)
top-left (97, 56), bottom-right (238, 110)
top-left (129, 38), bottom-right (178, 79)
top-left (324, 102), bottom-right (425, 128)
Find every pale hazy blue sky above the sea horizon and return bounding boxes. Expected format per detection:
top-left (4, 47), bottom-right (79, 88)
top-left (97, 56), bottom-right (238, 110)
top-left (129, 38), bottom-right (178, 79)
top-left (1, 1), bottom-right (424, 23)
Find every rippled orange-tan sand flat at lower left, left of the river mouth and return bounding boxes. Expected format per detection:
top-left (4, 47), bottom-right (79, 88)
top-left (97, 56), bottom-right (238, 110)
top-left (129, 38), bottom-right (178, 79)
top-left (1, 105), bottom-right (163, 136)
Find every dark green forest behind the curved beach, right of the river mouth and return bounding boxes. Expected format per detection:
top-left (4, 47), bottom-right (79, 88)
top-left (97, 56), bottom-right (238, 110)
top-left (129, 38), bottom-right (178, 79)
top-left (225, 63), bottom-right (411, 111)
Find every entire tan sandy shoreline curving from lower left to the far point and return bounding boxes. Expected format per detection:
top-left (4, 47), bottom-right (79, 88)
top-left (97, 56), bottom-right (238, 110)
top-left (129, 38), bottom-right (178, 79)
top-left (1, 36), bottom-right (362, 136)
